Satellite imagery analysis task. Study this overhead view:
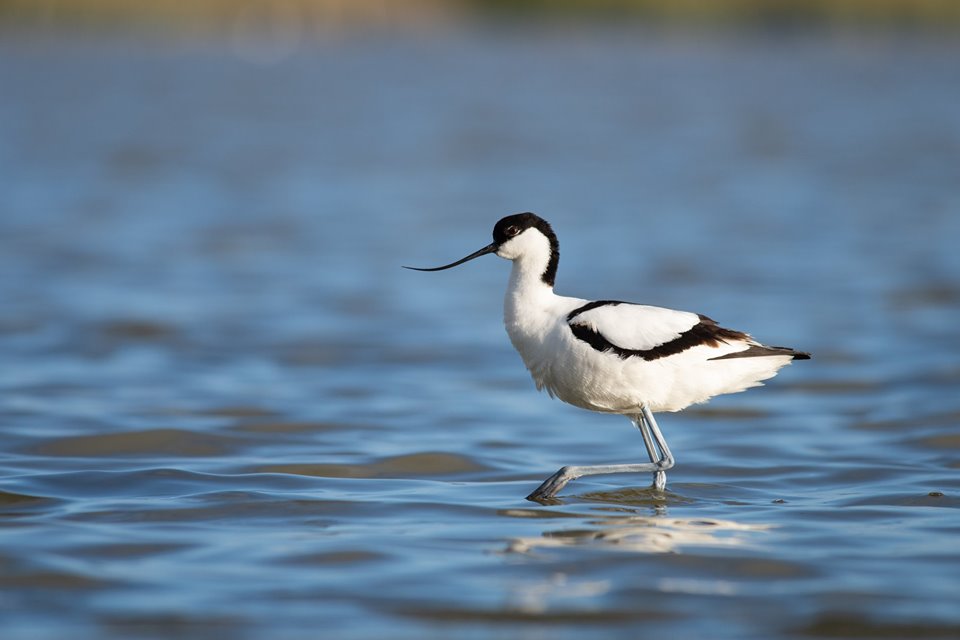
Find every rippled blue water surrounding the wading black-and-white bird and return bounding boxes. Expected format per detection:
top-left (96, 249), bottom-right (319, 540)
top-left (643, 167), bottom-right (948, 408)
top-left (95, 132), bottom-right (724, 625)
top-left (0, 31), bottom-right (960, 639)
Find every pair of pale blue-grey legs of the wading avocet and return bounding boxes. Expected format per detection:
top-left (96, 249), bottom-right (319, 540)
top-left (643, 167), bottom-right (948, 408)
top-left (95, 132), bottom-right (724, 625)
top-left (527, 406), bottom-right (674, 502)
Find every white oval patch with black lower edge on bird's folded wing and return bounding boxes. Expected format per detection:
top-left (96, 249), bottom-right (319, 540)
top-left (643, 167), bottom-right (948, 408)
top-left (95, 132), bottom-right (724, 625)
top-left (567, 300), bottom-right (701, 355)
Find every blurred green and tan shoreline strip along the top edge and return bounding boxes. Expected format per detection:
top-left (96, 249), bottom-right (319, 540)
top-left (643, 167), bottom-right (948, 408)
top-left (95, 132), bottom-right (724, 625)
top-left (0, 0), bottom-right (960, 36)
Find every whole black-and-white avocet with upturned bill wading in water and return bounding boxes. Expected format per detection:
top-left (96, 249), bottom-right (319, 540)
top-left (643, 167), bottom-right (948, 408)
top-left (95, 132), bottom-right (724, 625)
top-left (406, 213), bottom-right (809, 500)
